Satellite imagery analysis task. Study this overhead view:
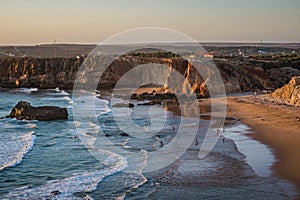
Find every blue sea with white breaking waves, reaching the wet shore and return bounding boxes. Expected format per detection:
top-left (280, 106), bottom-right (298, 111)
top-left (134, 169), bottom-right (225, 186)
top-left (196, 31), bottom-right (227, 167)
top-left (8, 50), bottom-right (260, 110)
top-left (0, 88), bottom-right (297, 199)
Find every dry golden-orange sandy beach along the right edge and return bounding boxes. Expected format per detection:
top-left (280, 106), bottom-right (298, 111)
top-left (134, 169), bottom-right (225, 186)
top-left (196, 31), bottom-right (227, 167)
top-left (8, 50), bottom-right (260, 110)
top-left (223, 96), bottom-right (300, 199)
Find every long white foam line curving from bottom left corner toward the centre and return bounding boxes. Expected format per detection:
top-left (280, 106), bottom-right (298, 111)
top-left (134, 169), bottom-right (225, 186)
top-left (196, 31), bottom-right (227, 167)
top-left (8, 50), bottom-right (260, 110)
top-left (6, 117), bottom-right (127, 199)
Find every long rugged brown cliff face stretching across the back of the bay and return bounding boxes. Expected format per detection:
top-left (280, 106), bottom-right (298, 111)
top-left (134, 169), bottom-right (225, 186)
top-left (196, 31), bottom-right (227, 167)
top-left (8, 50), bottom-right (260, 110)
top-left (0, 57), bottom-right (300, 97)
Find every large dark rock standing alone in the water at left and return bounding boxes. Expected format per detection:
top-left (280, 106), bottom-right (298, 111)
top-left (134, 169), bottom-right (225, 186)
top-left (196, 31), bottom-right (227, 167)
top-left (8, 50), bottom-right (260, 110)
top-left (7, 101), bottom-right (68, 121)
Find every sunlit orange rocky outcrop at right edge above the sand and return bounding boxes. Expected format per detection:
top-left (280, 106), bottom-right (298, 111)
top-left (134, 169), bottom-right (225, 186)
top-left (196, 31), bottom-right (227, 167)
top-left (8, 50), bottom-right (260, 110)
top-left (271, 76), bottom-right (300, 106)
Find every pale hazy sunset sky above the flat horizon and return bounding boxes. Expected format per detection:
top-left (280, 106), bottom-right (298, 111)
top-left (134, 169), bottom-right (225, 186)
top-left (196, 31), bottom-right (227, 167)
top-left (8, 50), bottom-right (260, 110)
top-left (0, 0), bottom-right (300, 44)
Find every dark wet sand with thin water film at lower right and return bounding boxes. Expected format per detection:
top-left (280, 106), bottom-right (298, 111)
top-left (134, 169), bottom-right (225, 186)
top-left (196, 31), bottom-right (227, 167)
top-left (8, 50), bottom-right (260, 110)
top-left (147, 120), bottom-right (290, 199)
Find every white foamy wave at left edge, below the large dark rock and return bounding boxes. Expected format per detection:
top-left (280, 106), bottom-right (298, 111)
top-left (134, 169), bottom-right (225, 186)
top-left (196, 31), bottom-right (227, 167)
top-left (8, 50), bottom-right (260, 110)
top-left (0, 131), bottom-right (35, 170)
